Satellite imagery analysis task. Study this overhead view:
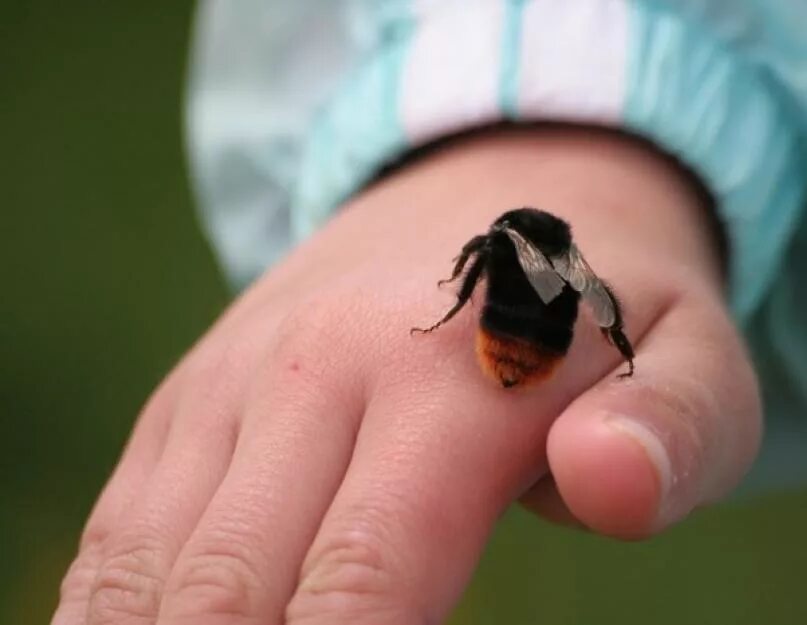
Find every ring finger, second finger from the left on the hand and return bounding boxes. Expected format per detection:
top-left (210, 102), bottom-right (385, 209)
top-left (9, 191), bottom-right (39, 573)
top-left (87, 398), bottom-right (237, 625)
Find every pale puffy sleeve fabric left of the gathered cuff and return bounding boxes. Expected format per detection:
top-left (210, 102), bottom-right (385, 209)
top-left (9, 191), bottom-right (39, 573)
top-left (187, 0), bottom-right (378, 288)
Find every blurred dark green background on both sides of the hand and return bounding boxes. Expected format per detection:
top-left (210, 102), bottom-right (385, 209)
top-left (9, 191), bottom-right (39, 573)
top-left (0, 0), bottom-right (807, 625)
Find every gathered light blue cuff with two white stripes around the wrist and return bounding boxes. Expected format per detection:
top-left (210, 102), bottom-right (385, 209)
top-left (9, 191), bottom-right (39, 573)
top-left (293, 0), bottom-right (805, 318)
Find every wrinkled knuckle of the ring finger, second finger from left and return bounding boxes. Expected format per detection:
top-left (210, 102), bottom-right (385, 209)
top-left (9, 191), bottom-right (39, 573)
top-left (88, 537), bottom-right (163, 625)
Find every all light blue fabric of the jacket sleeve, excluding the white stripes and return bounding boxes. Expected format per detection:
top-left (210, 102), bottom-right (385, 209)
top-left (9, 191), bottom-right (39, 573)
top-left (189, 0), bottom-right (807, 488)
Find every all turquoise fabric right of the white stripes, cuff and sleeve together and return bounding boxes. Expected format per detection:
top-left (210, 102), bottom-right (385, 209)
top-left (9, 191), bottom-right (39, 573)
top-left (625, 0), bottom-right (807, 492)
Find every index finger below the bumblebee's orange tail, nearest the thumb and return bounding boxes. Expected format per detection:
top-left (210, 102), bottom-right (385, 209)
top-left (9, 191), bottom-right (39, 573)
top-left (286, 355), bottom-right (576, 625)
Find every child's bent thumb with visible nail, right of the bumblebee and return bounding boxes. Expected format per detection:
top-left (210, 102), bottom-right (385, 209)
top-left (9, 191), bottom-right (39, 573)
top-left (548, 287), bottom-right (761, 538)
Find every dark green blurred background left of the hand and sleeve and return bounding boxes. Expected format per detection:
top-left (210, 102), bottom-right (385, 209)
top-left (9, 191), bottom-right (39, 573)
top-left (0, 0), bottom-right (226, 625)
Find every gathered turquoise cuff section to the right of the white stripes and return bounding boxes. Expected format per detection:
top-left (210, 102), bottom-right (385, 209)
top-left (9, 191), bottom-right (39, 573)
top-left (624, 2), bottom-right (807, 320)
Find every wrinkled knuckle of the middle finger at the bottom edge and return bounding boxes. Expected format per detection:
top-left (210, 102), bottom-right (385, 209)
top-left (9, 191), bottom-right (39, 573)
top-left (163, 537), bottom-right (263, 618)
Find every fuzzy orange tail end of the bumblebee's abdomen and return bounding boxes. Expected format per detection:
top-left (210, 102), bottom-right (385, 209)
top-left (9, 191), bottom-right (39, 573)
top-left (476, 328), bottom-right (563, 388)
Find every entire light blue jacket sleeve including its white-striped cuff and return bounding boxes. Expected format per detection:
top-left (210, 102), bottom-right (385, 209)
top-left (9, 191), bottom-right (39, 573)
top-left (189, 0), bottom-right (807, 490)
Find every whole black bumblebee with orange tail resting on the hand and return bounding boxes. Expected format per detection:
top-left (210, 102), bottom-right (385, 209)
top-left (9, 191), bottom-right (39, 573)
top-left (411, 208), bottom-right (634, 388)
